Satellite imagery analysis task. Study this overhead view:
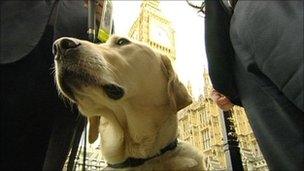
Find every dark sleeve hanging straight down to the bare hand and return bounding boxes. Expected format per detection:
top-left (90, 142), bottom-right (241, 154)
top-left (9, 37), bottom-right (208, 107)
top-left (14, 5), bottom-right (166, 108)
top-left (205, 0), bottom-right (241, 105)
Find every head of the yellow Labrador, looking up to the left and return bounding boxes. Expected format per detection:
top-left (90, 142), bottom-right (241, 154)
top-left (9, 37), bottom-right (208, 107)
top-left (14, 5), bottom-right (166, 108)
top-left (53, 36), bottom-right (191, 143)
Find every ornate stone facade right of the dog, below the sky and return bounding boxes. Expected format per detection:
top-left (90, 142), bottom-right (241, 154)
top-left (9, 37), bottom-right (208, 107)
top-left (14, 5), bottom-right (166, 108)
top-left (178, 71), bottom-right (268, 170)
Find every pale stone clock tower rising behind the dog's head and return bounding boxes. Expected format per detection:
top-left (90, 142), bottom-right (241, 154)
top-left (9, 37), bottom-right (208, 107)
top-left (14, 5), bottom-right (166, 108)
top-left (129, 0), bottom-right (175, 63)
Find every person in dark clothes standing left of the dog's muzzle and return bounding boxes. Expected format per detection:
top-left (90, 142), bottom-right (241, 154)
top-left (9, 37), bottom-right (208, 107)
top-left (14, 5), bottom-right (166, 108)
top-left (0, 0), bottom-right (87, 170)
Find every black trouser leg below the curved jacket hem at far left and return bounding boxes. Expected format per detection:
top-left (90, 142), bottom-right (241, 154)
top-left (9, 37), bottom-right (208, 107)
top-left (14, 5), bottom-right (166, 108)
top-left (0, 27), bottom-right (75, 170)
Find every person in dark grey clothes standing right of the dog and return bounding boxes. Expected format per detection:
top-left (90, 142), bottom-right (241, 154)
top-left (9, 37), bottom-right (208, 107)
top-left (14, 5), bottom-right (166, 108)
top-left (205, 0), bottom-right (304, 170)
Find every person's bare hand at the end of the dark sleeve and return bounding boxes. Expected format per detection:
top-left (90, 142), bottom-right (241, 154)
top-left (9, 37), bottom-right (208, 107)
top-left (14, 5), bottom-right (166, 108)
top-left (211, 90), bottom-right (234, 111)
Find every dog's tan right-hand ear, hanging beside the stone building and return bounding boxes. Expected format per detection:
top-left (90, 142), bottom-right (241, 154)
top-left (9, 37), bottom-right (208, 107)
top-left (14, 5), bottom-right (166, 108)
top-left (161, 55), bottom-right (192, 111)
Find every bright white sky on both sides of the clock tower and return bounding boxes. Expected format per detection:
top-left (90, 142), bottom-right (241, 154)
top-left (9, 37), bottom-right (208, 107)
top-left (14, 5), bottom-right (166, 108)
top-left (112, 0), bottom-right (207, 98)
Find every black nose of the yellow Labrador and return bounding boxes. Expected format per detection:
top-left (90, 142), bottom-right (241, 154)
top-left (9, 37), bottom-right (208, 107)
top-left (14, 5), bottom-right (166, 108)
top-left (52, 38), bottom-right (80, 58)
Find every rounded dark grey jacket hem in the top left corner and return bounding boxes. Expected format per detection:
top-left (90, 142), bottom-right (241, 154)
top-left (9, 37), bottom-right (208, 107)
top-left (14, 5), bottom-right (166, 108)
top-left (0, 0), bottom-right (55, 64)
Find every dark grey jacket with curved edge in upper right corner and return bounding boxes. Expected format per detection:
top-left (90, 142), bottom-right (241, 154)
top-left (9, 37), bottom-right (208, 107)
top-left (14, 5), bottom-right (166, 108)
top-left (230, 1), bottom-right (304, 112)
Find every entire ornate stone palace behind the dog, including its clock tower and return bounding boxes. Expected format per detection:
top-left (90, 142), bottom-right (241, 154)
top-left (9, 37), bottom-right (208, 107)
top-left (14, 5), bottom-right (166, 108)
top-left (66, 0), bottom-right (268, 170)
